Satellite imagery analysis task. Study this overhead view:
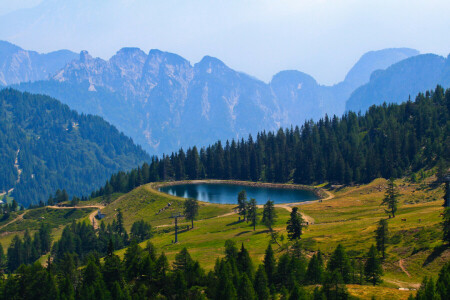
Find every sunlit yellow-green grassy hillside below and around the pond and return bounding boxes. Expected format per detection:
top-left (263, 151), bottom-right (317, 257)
top-left (0, 175), bottom-right (450, 299)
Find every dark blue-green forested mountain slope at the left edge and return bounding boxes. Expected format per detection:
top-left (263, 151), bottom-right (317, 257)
top-left (0, 89), bottom-right (149, 206)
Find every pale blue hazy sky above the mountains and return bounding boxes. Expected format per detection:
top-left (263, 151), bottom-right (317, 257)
top-left (0, 0), bottom-right (450, 84)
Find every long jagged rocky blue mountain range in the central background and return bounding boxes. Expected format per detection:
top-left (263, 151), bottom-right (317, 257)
top-left (9, 43), bottom-right (418, 154)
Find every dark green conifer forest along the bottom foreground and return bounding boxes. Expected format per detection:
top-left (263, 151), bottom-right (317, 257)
top-left (0, 219), bottom-right (450, 300)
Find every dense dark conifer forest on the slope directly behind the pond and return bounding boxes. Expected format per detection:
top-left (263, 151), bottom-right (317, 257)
top-left (91, 86), bottom-right (450, 197)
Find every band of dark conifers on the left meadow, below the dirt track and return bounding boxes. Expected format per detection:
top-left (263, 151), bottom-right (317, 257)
top-left (0, 210), bottom-right (152, 273)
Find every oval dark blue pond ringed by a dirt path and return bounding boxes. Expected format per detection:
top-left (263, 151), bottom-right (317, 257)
top-left (158, 183), bottom-right (319, 204)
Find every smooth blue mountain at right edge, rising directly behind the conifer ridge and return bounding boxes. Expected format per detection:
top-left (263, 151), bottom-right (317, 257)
top-left (346, 54), bottom-right (450, 112)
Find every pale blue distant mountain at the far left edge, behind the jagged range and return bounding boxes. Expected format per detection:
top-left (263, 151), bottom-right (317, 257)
top-left (0, 41), bottom-right (78, 85)
